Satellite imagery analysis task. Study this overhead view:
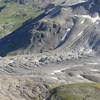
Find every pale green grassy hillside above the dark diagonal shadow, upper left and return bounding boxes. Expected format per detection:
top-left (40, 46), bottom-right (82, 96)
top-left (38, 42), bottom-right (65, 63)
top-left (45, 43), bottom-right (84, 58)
top-left (0, 1), bottom-right (40, 37)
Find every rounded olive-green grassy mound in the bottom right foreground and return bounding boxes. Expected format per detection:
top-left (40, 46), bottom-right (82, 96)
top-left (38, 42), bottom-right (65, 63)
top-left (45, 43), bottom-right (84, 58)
top-left (50, 83), bottom-right (100, 100)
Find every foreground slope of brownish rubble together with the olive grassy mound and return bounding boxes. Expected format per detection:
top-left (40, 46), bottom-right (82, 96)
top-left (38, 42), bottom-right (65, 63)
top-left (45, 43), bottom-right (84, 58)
top-left (0, 76), bottom-right (100, 100)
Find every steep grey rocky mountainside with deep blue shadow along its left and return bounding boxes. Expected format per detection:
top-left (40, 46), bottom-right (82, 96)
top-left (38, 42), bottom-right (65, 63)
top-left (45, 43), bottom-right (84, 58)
top-left (0, 0), bottom-right (100, 56)
